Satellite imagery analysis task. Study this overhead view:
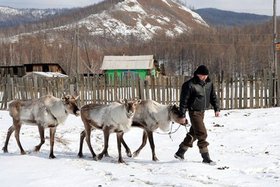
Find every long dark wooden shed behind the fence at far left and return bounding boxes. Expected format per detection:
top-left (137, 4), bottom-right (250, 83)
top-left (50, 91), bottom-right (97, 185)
top-left (0, 63), bottom-right (66, 77)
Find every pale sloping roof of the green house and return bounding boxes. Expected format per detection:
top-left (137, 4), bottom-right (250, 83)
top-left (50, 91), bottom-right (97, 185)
top-left (100, 55), bottom-right (154, 70)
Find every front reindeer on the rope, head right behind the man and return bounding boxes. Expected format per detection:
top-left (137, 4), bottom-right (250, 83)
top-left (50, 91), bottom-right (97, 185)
top-left (121, 100), bottom-right (185, 161)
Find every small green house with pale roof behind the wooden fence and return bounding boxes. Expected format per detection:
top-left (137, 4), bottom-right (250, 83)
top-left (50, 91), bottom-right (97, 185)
top-left (100, 55), bottom-right (156, 79)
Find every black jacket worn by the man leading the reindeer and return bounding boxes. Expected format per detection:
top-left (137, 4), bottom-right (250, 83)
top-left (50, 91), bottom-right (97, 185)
top-left (180, 74), bottom-right (220, 117)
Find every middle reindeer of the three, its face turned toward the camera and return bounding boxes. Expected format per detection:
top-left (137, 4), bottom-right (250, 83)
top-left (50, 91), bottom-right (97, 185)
top-left (78, 100), bottom-right (141, 163)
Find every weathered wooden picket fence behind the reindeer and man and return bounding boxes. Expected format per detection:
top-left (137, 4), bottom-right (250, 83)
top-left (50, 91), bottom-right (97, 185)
top-left (0, 73), bottom-right (279, 109)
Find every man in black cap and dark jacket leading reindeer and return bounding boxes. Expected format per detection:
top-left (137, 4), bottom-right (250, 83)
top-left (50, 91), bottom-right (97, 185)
top-left (174, 65), bottom-right (220, 165)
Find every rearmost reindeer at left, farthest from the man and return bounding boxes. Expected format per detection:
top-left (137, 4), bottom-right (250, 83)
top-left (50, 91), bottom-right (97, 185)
top-left (3, 95), bottom-right (80, 159)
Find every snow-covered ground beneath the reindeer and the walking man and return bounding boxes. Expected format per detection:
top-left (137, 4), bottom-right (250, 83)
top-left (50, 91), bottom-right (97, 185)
top-left (0, 108), bottom-right (280, 187)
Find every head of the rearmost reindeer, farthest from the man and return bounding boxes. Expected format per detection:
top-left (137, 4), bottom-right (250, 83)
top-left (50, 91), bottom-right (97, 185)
top-left (61, 95), bottom-right (80, 116)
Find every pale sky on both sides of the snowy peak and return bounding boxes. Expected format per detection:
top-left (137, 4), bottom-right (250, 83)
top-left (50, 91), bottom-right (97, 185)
top-left (0, 0), bottom-right (280, 16)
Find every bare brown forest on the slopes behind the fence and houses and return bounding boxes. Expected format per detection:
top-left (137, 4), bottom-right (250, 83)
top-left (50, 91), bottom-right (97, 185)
top-left (0, 0), bottom-right (279, 75)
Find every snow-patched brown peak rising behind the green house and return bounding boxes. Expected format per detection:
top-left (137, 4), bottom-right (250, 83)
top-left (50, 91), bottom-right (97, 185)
top-left (69, 0), bottom-right (208, 39)
